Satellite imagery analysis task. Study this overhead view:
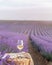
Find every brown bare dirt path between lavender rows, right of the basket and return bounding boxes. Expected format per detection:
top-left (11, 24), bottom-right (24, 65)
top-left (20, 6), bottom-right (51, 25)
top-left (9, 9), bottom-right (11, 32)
top-left (29, 40), bottom-right (48, 65)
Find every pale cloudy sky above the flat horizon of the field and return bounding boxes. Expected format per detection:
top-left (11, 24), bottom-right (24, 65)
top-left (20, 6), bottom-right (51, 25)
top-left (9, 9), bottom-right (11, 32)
top-left (0, 0), bottom-right (52, 20)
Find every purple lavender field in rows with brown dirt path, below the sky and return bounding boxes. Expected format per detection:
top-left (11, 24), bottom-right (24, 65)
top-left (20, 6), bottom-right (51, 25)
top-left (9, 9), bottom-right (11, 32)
top-left (0, 21), bottom-right (52, 65)
